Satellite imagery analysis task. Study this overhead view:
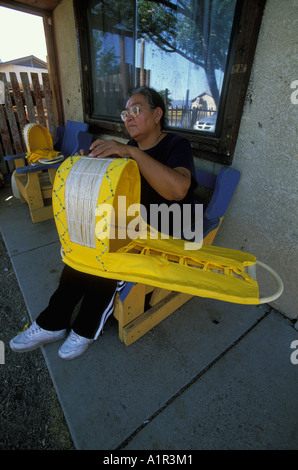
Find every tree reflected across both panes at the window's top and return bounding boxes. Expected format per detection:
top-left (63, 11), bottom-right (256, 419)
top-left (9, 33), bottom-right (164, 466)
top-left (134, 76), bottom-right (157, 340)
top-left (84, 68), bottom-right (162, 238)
top-left (91, 0), bottom-right (236, 106)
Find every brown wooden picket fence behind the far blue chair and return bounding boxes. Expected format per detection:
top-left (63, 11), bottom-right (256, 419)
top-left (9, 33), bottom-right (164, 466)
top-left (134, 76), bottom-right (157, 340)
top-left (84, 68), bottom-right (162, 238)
top-left (0, 72), bottom-right (56, 174)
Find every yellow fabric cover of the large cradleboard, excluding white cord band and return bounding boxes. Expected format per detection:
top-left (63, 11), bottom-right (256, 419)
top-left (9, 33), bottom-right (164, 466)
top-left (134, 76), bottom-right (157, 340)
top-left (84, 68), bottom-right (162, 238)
top-left (53, 157), bottom-right (259, 304)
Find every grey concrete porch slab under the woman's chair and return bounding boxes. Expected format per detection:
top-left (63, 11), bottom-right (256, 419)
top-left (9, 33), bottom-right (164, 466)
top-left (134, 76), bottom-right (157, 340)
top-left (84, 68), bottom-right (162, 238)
top-left (0, 189), bottom-right (298, 450)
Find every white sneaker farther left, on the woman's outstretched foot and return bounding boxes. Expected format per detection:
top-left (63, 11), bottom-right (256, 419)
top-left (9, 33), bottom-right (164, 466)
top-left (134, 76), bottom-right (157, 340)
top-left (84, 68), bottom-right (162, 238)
top-left (9, 322), bottom-right (66, 352)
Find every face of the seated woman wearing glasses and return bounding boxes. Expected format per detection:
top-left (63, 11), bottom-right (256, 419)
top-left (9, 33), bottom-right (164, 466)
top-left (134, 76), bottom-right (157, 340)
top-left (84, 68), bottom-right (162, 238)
top-left (125, 93), bottom-right (162, 141)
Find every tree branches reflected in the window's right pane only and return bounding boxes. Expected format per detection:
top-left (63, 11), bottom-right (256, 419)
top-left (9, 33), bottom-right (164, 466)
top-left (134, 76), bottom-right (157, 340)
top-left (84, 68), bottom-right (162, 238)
top-left (138, 0), bottom-right (236, 106)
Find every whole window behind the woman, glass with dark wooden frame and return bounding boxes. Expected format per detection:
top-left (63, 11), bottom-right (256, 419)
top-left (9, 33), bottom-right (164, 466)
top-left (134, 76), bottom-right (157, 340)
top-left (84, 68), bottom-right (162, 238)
top-left (75, 0), bottom-right (265, 163)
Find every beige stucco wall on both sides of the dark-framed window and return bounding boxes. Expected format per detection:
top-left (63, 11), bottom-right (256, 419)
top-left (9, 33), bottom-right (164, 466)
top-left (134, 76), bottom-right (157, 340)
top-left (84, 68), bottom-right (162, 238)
top-left (55, 0), bottom-right (298, 318)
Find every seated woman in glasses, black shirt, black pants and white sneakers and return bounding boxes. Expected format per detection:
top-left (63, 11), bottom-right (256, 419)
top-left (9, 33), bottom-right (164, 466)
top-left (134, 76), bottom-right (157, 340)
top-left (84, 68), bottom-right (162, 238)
top-left (10, 87), bottom-right (196, 359)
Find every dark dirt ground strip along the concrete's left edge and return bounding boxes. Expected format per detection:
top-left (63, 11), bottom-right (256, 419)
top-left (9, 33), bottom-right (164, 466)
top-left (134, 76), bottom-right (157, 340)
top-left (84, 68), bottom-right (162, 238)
top-left (0, 229), bottom-right (74, 450)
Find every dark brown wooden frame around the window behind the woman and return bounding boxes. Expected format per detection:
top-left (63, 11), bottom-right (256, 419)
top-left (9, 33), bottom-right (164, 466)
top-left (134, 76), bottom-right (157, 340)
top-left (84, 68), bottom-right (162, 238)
top-left (74, 0), bottom-right (266, 165)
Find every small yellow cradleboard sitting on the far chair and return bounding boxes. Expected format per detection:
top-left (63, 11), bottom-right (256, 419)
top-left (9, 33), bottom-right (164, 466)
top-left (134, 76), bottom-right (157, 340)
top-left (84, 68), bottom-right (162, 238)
top-left (23, 123), bottom-right (63, 165)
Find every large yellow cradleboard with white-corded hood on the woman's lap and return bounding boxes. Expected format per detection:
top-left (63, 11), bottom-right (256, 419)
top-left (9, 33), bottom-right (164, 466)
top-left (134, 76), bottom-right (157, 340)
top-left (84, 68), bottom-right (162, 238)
top-left (53, 157), bottom-right (283, 304)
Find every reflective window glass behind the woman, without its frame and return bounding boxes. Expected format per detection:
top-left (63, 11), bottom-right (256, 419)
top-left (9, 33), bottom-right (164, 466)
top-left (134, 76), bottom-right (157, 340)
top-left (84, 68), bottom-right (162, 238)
top-left (88, 0), bottom-right (236, 133)
